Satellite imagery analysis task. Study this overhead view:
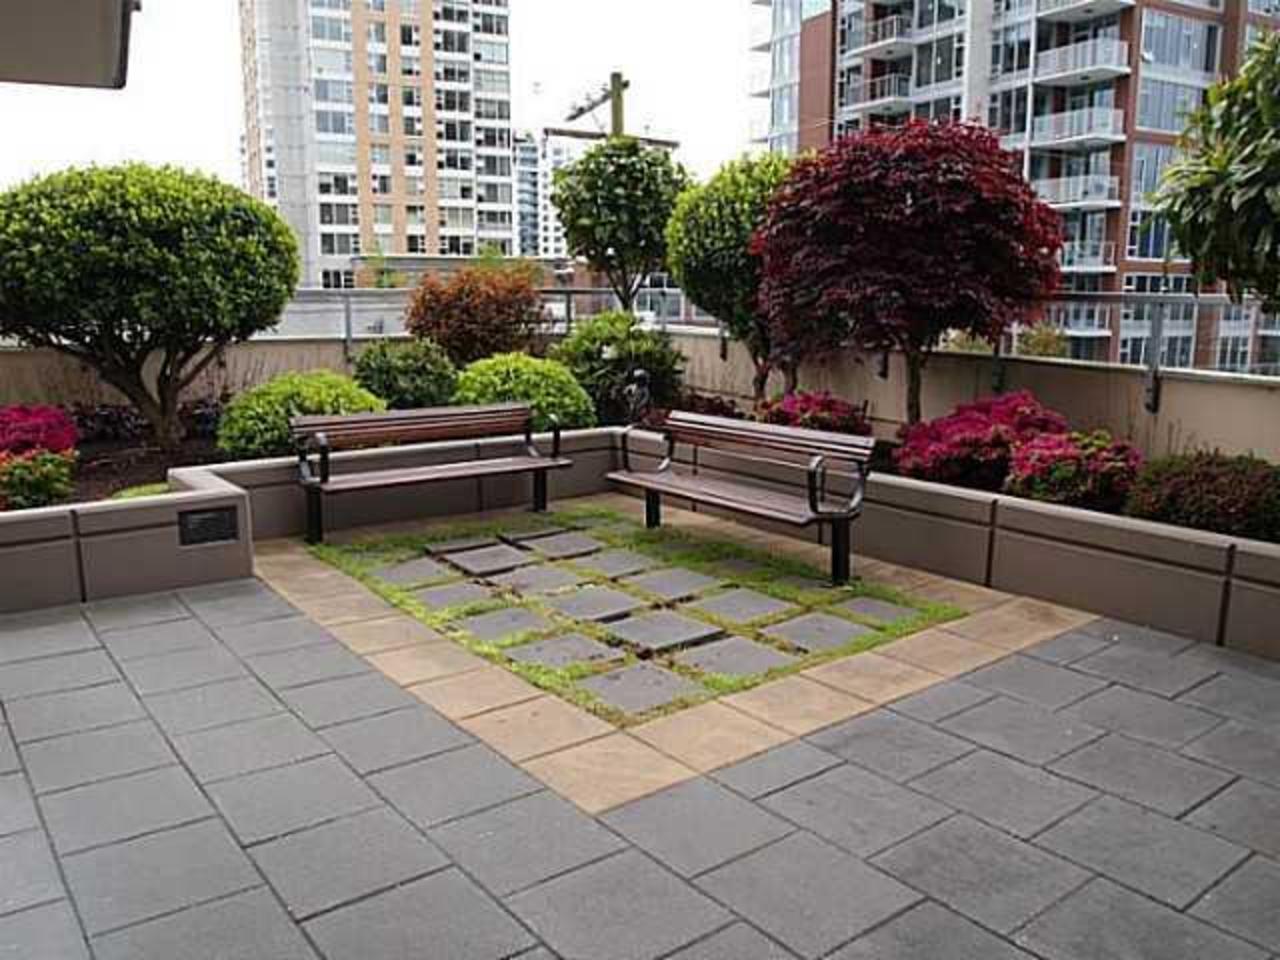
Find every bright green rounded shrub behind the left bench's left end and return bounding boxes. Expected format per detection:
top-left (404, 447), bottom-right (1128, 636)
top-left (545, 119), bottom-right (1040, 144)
top-left (218, 370), bottom-right (387, 458)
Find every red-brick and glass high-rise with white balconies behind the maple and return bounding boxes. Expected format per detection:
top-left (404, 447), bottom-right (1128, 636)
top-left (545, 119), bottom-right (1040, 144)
top-left (751, 0), bottom-right (1280, 372)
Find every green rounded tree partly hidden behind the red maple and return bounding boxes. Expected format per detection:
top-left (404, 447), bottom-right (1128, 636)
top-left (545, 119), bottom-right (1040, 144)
top-left (667, 154), bottom-right (791, 404)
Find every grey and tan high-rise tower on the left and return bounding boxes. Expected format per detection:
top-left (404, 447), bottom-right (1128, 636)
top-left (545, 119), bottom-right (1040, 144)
top-left (241, 0), bottom-right (517, 287)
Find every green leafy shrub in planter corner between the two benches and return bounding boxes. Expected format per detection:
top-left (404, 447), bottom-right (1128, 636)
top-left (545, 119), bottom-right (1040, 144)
top-left (552, 312), bottom-right (685, 424)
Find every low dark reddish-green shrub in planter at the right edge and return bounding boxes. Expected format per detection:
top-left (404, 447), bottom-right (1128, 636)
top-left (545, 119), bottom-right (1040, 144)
top-left (1126, 453), bottom-right (1280, 543)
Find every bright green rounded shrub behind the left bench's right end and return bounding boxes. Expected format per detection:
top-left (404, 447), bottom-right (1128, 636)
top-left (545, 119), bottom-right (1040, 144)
top-left (453, 353), bottom-right (596, 430)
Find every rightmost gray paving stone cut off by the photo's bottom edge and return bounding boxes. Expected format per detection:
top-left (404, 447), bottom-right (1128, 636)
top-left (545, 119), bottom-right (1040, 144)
top-left (1016, 879), bottom-right (1263, 960)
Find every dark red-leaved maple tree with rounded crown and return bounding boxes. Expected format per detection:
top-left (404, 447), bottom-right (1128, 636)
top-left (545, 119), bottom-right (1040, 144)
top-left (754, 122), bottom-right (1062, 424)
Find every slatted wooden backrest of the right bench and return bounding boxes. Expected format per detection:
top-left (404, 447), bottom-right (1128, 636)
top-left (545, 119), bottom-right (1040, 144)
top-left (666, 411), bottom-right (876, 463)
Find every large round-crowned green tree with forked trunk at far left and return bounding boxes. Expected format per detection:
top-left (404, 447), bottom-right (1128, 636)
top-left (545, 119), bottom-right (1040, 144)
top-left (0, 164), bottom-right (298, 449)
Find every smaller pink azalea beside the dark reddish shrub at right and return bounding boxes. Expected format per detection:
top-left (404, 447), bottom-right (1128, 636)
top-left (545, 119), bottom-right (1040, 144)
top-left (1005, 430), bottom-right (1142, 513)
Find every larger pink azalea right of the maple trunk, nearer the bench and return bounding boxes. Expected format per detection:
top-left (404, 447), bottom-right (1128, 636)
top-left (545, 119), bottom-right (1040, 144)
top-left (893, 390), bottom-right (1068, 492)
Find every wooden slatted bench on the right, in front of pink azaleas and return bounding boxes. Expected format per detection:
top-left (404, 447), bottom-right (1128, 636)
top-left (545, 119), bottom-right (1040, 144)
top-left (609, 412), bottom-right (876, 584)
